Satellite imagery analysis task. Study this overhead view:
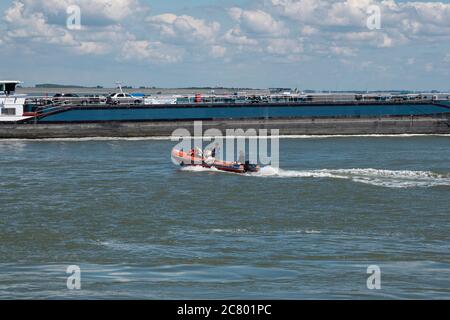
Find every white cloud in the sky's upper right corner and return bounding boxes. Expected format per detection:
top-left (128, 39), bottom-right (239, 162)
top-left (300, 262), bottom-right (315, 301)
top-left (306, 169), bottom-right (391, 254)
top-left (270, 0), bottom-right (450, 42)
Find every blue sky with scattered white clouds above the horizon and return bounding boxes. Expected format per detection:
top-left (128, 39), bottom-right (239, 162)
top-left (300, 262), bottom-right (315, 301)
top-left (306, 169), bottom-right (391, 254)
top-left (0, 0), bottom-right (450, 91)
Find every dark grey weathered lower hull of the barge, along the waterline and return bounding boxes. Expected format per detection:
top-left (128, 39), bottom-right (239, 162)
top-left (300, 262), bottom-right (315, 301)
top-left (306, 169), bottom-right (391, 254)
top-left (0, 114), bottom-right (450, 139)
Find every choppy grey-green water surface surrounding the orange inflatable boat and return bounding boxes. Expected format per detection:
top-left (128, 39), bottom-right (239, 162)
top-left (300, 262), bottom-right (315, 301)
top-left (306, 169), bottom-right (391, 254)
top-left (0, 136), bottom-right (450, 299)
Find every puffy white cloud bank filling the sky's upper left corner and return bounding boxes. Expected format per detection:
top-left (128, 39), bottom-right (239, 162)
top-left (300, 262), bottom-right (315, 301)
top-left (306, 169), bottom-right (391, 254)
top-left (3, 0), bottom-right (178, 62)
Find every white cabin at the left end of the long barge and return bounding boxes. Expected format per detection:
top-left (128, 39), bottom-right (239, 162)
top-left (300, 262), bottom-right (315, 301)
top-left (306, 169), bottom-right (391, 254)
top-left (0, 80), bottom-right (32, 122)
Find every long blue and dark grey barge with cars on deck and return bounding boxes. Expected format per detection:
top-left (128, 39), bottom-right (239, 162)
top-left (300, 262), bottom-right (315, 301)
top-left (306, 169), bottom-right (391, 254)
top-left (0, 81), bottom-right (450, 139)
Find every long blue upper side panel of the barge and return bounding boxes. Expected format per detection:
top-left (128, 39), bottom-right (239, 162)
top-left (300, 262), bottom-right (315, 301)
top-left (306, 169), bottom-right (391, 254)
top-left (38, 101), bottom-right (450, 123)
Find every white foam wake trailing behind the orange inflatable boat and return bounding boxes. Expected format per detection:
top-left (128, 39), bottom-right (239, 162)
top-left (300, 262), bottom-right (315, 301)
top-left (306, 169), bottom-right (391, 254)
top-left (251, 166), bottom-right (450, 188)
